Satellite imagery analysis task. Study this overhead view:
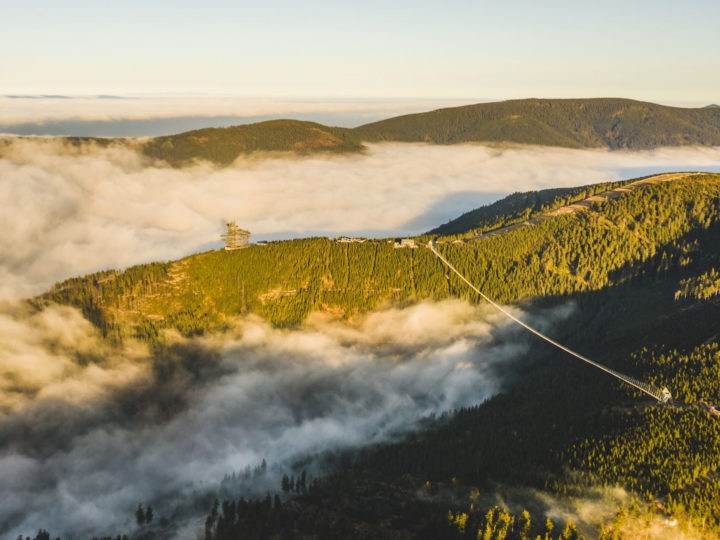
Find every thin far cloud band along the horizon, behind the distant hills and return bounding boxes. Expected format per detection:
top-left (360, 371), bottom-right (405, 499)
top-left (0, 95), bottom-right (467, 133)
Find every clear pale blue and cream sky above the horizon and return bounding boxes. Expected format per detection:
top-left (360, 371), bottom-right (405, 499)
top-left (0, 0), bottom-right (720, 104)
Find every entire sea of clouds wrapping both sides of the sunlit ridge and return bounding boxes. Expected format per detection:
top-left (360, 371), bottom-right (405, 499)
top-left (0, 134), bottom-right (720, 538)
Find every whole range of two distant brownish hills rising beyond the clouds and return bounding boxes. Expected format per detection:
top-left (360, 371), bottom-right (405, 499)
top-left (5, 98), bottom-right (720, 166)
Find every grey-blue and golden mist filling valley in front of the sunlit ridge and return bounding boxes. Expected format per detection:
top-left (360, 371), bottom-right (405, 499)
top-left (0, 300), bottom-right (556, 538)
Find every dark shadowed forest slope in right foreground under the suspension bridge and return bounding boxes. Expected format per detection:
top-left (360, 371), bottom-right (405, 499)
top-left (193, 193), bottom-right (720, 540)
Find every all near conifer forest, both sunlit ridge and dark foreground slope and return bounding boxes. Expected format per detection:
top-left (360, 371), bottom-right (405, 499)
top-left (19, 174), bottom-right (720, 540)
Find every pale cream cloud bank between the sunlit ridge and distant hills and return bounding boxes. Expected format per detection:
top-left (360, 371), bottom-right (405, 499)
top-left (0, 140), bottom-right (720, 298)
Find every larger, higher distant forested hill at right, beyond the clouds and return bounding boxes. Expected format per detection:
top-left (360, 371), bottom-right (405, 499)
top-left (355, 98), bottom-right (720, 150)
